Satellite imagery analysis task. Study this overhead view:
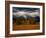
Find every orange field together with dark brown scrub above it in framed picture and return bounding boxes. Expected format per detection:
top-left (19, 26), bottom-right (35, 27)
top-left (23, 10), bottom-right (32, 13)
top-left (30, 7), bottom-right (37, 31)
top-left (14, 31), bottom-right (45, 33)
top-left (13, 18), bottom-right (40, 30)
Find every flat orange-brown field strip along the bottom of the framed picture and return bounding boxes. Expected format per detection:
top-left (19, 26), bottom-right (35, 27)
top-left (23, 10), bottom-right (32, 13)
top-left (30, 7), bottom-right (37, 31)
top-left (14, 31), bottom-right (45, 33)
top-left (13, 24), bottom-right (40, 30)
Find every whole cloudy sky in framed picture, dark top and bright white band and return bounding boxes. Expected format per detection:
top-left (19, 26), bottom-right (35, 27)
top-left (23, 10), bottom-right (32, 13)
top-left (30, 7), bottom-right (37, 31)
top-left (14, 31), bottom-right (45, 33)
top-left (13, 7), bottom-right (40, 17)
